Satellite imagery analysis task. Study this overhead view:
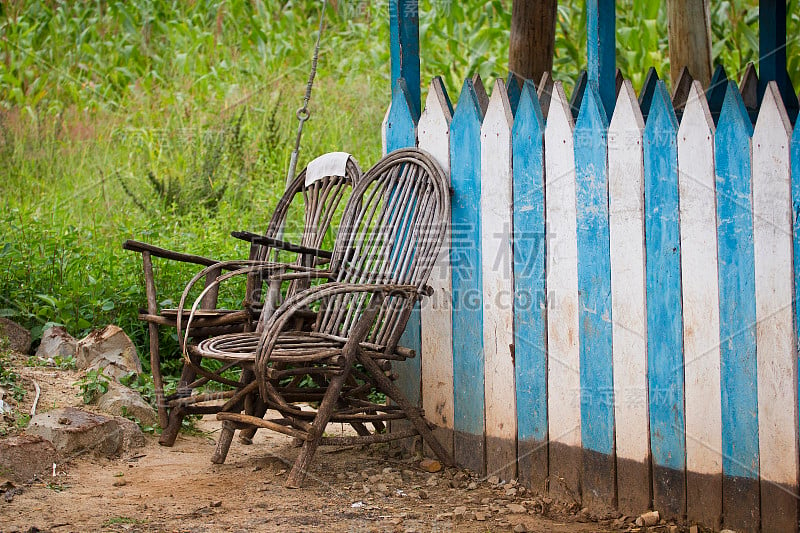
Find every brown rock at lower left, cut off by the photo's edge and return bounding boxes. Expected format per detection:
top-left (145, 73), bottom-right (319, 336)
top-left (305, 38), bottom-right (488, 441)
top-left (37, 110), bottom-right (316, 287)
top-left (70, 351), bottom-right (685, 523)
top-left (0, 435), bottom-right (59, 483)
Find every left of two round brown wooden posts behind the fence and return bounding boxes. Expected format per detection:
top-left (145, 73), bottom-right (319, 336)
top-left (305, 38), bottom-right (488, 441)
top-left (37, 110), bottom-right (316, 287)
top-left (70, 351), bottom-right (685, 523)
top-left (508, 0), bottom-right (558, 81)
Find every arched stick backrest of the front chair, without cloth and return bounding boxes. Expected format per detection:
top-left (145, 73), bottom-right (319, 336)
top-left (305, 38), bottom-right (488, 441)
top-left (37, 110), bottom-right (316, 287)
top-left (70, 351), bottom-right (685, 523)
top-left (315, 148), bottom-right (450, 350)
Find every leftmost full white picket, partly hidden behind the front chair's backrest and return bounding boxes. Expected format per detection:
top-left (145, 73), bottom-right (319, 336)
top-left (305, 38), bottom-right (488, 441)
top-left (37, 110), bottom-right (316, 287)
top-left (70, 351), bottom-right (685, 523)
top-left (417, 78), bottom-right (454, 444)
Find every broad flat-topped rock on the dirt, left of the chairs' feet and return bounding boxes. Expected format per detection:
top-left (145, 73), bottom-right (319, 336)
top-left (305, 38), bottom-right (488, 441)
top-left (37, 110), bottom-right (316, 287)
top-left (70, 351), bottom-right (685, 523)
top-left (26, 407), bottom-right (122, 458)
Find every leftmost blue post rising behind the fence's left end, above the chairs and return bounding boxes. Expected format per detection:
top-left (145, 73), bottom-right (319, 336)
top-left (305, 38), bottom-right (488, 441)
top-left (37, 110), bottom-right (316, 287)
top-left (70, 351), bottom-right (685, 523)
top-left (389, 0), bottom-right (421, 119)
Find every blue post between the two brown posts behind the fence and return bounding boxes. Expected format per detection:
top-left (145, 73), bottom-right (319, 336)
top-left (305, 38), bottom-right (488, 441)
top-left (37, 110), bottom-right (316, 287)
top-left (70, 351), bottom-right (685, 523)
top-left (586, 0), bottom-right (617, 122)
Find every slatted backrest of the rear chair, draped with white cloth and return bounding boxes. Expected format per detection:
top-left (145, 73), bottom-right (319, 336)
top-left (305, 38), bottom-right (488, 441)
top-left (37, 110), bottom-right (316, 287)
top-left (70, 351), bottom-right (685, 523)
top-left (241, 152), bottom-right (362, 305)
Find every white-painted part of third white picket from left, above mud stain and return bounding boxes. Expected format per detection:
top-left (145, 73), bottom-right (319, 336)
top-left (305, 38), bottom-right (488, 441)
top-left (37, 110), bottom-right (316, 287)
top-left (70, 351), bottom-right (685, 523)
top-left (545, 81), bottom-right (581, 447)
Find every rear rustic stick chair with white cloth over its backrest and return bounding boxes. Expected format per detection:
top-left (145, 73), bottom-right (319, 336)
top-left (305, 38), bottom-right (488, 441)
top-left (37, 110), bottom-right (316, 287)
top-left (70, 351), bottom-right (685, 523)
top-left (123, 153), bottom-right (361, 446)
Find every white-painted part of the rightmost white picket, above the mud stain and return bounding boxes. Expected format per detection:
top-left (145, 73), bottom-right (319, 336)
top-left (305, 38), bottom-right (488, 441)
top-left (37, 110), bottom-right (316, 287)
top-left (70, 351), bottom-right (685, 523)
top-left (753, 82), bottom-right (798, 486)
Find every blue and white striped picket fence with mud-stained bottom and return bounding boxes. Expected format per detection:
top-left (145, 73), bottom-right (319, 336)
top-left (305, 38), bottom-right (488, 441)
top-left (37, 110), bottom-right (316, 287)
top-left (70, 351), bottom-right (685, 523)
top-left (384, 69), bottom-right (800, 531)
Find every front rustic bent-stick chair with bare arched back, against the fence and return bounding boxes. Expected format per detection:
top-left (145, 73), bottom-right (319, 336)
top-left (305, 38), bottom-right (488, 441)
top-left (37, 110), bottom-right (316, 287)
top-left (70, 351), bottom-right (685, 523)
top-left (186, 149), bottom-right (452, 487)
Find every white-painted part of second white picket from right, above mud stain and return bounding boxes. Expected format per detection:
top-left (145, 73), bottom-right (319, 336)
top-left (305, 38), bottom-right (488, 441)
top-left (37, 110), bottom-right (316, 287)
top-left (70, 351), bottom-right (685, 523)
top-left (678, 81), bottom-right (720, 474)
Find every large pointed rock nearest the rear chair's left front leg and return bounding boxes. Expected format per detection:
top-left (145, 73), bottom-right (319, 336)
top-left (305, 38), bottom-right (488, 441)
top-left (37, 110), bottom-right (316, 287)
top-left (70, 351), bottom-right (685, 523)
top-left (75, 324), bottom-right (142, 381)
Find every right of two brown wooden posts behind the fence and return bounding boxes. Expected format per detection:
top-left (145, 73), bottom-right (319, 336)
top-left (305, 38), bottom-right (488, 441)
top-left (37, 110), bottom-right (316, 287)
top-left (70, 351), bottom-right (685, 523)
top-left (667, 0), bottom-right (716, 87)
